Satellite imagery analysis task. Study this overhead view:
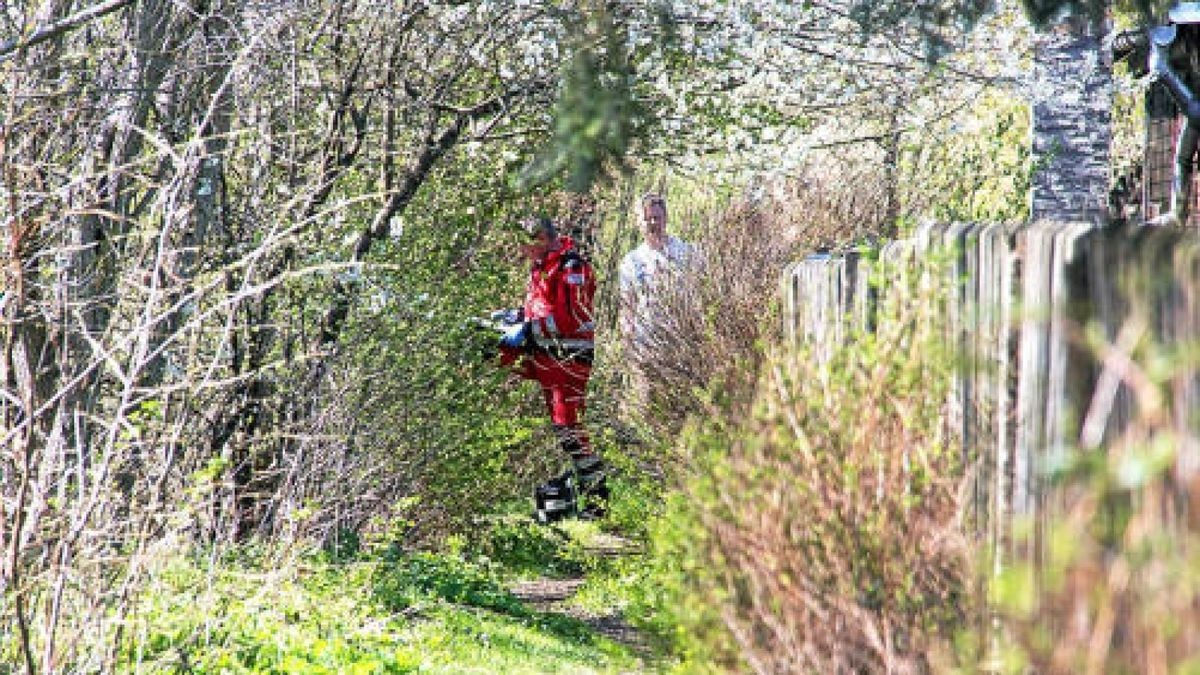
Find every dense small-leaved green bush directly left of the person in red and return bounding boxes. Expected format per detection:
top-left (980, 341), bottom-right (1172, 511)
top-left (280, 180), bottom-right (552, 542)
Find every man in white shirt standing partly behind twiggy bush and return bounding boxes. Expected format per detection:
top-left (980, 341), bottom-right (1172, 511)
top-left (619, 192), bottom-right (696, 406)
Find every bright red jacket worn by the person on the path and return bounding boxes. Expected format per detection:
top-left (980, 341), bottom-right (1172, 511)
top-left (524, 235), bottom-right (596, 348)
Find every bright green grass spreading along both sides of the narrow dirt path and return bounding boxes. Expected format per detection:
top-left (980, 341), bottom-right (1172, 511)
top-left (98, 466), bottom-right (672, 674)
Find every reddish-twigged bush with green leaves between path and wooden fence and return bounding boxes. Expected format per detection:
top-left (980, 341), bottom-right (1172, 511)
top-left (653, 253), bottom-right (970, 673)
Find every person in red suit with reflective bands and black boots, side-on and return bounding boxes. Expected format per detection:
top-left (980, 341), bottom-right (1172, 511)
top-left (500, 217), bottom-right (608, 521)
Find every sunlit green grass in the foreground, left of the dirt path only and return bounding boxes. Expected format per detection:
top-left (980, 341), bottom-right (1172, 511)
top-left (120, 540), bottom-right (642, 674)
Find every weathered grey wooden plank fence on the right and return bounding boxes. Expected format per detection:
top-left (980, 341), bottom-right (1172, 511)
top-left (781, 222), bottom-right (1200, 554)
